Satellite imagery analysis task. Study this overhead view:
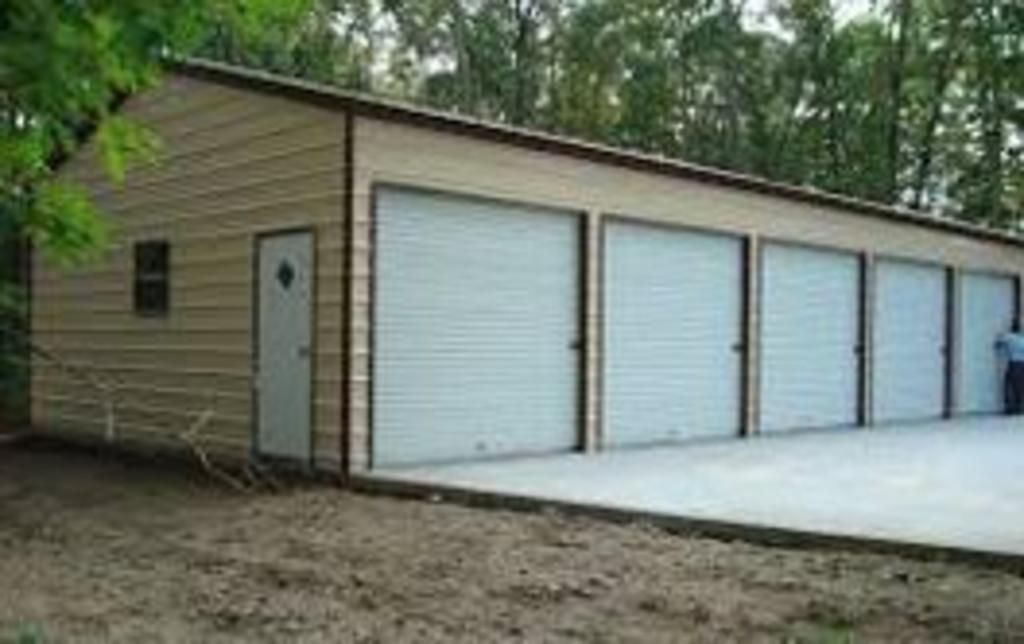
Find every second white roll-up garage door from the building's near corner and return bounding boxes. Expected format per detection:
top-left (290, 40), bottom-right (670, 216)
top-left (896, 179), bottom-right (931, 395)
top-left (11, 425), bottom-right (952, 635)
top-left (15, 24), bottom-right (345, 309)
top-left (603, 222), bottom-right (742, 445)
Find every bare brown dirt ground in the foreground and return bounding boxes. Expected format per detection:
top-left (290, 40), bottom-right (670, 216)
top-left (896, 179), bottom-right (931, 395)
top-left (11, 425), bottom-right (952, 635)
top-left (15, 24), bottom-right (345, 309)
top-left (0, 446), bottom-right (1024, 643)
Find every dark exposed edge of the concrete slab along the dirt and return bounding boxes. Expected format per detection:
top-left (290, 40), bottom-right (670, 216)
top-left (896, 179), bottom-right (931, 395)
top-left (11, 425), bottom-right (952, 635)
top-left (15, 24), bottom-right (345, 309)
top-left (349, 474), bottom-right (1024, 575)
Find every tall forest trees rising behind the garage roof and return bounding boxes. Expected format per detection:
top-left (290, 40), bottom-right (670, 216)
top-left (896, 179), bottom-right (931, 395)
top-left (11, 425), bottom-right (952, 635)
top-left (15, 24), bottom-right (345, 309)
top-left (203, 0), bottom-right (1024, 229)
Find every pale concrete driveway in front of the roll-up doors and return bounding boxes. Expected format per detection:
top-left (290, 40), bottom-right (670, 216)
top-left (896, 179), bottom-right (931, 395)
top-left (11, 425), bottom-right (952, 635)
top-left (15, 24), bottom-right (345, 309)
top-left (373, 417), bottom-right (1024, 556)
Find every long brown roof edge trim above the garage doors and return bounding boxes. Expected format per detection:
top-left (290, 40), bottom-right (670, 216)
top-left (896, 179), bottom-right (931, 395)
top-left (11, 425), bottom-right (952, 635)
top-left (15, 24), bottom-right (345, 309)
top-left (170, 58), bottom-right (1024, 247)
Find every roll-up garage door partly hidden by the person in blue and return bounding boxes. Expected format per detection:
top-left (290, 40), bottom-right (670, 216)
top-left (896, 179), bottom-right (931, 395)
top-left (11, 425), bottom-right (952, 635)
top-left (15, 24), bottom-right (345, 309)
top-left (956, 272), bottom-right (1016, 414)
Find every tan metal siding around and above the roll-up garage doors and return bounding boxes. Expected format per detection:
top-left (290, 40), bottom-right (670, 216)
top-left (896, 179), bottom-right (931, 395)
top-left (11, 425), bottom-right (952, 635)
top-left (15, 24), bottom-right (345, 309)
top-left (349, 117), bottom-right (1024, 470)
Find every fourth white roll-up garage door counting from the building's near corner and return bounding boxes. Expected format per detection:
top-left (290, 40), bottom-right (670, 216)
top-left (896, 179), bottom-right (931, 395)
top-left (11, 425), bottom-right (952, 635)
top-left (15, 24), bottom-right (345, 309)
top-left (871, 260), bottom-right (946, 423)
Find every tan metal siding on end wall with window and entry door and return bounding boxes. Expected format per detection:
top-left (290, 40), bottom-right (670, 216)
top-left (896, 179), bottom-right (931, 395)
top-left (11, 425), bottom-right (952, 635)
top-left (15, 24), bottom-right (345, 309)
top-left (33, 77), bottom-right (345, 470)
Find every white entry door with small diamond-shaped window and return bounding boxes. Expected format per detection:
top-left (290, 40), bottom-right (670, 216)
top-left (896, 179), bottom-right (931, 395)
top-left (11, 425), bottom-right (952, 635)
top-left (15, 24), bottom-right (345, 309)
top-left (256, 228), bottom-right (313, 461)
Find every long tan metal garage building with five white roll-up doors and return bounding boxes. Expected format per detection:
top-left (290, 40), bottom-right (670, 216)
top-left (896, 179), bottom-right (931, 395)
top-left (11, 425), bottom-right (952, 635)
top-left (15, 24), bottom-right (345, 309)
top-left (25, 61), bottom-right (1024, 472)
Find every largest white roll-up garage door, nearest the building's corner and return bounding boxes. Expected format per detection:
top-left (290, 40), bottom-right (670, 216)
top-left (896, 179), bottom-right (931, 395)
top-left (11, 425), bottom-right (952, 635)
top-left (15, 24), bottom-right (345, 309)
top-left (373, 189), bottom-right (580, 466)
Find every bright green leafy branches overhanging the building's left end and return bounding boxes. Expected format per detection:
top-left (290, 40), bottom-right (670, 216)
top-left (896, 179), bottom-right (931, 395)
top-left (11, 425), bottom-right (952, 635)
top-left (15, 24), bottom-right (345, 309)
top-left (0, 0), bottom-right (311, 262)
